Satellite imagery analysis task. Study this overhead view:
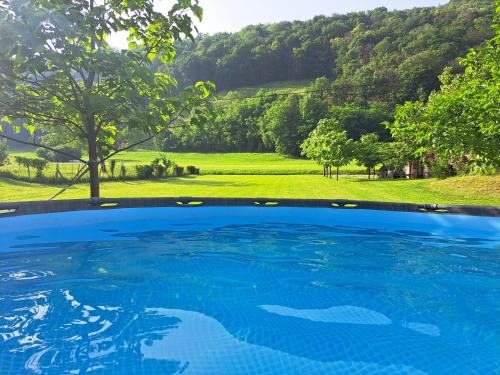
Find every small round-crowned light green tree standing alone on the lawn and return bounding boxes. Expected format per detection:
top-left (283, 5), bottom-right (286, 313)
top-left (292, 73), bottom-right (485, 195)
top-left (301, 119), bottom-right (354, 181)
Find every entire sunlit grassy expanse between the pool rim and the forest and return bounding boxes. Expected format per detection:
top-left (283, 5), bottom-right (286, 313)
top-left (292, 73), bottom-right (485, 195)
top-left (0, 151), bottom-right (500, 205)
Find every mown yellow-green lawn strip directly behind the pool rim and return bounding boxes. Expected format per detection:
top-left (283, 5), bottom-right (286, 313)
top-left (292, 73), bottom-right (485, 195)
top-left (0, 175), bottom-right (500, 205)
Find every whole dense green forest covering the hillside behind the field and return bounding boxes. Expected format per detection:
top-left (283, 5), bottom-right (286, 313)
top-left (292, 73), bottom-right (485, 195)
top-left (155, 0), bottom-right (495, 156)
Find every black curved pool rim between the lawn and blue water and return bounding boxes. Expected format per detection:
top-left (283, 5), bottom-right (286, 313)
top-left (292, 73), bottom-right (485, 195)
top-left (0, 197), bottom-right (500, 218)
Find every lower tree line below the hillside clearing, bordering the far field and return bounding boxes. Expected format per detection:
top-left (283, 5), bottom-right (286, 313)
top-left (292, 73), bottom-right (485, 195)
top-left (155, 77), bottom-right (392, 156)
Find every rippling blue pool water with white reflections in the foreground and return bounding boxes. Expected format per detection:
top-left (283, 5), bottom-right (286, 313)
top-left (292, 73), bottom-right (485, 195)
top-left (0, 207), bottom-right (500, 375)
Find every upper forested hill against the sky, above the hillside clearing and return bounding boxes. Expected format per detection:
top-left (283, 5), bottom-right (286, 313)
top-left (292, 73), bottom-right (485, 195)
top-left (171, 0), bottom-right (494, 104)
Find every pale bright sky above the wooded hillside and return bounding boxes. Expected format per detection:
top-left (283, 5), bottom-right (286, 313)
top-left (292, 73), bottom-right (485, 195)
top-left (110, 0), bottom-right (448, 47)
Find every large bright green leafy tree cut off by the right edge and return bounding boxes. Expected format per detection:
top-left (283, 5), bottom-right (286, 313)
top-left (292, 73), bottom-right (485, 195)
top-left (389, 10), bottom-right (500, 170)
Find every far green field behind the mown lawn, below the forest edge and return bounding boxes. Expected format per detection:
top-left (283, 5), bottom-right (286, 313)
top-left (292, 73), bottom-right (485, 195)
top-left (0, 151), bottom-right (365, 177)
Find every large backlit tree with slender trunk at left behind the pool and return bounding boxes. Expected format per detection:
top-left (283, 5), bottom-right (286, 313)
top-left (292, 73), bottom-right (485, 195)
top-left (0, 0), bottom-right (212, 198)
